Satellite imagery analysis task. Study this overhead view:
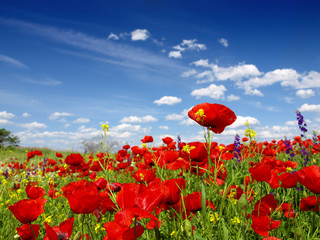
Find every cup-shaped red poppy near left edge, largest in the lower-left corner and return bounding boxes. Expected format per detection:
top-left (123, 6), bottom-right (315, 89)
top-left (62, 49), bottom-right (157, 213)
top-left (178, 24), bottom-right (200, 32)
top-left (8, 198), bottom-right (48, 224)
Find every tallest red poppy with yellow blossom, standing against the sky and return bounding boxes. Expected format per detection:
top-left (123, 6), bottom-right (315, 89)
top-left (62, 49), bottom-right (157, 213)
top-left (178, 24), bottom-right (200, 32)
top-left (188, 103), bottom-right (237, 133)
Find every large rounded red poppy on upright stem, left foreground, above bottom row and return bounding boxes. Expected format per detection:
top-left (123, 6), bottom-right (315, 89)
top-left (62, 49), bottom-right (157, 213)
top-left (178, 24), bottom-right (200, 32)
top-left (61, 180), bottom-right (99, 214)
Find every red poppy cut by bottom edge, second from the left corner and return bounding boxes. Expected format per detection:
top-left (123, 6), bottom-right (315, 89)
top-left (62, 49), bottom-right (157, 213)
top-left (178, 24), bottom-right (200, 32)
top-left (43, 217), bottom-right (74, 240)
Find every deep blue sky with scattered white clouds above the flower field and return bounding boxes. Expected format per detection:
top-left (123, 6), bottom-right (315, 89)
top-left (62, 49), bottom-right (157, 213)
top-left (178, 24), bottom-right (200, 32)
top-left (0, 0), bottom-right (320, 150)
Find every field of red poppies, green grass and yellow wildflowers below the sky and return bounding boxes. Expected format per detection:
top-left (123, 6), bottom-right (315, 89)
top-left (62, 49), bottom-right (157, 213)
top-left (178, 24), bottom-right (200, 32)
top-left (0, 103), bottom-right (320, 240)
